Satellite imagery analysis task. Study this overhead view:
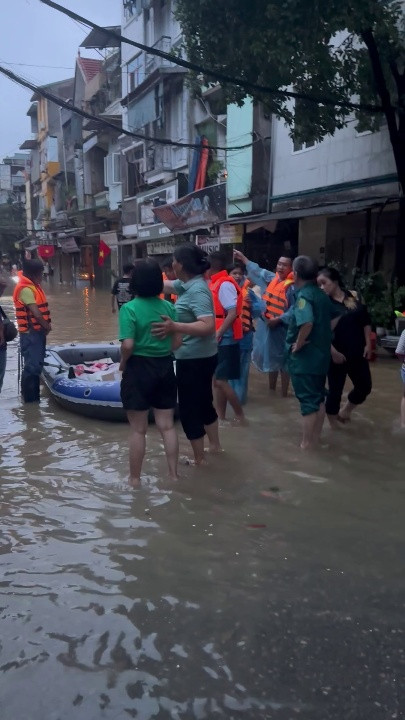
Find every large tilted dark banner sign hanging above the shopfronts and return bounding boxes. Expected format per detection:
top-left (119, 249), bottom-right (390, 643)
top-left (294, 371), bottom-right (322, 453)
top-left (154, 183), bottom-right (226, 232)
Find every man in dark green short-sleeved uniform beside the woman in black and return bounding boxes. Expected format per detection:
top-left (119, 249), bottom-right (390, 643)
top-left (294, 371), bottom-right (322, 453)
top-left (286, 255), bottom-right (338, 450)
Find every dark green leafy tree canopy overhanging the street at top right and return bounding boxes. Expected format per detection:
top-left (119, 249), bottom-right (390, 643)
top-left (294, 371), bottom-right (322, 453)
top-left (177, 0), bottom-right (405, 141)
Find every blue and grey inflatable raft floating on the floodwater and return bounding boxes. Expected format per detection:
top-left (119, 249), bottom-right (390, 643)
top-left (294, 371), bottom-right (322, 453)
top-left (42, 343), bottom-right (127, 422)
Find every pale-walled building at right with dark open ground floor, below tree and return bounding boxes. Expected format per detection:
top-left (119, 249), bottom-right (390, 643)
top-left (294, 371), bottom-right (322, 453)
top-left (271, 119), bottom-right (398, 273)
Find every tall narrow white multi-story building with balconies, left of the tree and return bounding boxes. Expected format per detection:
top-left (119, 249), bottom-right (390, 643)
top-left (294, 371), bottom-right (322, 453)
top-left (121, 0), bottom-right (192, 257)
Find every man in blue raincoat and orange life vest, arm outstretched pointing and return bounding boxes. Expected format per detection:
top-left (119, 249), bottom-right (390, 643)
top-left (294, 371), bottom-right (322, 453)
top-left (234, 250), bottom-right (295, 397)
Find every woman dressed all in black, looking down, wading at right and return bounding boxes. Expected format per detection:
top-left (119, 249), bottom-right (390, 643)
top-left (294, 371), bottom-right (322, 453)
top-left (318, 268), bottom-right (372, 426)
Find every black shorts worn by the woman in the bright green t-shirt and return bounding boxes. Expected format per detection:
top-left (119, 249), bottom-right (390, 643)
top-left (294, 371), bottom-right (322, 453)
top-left (121, 355), bottom-right (177, 411)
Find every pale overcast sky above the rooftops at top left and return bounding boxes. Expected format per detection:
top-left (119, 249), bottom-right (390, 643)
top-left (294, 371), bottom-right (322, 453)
top-left (0, 0), bottom-right (121, 161)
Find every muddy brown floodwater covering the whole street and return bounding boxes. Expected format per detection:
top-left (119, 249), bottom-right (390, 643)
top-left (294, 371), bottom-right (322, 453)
top-left (0, 288), bottom-right (405, 720)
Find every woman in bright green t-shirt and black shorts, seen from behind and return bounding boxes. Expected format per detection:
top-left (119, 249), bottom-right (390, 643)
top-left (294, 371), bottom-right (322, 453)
top-left (119, 260), bottom-right (181, 487)
